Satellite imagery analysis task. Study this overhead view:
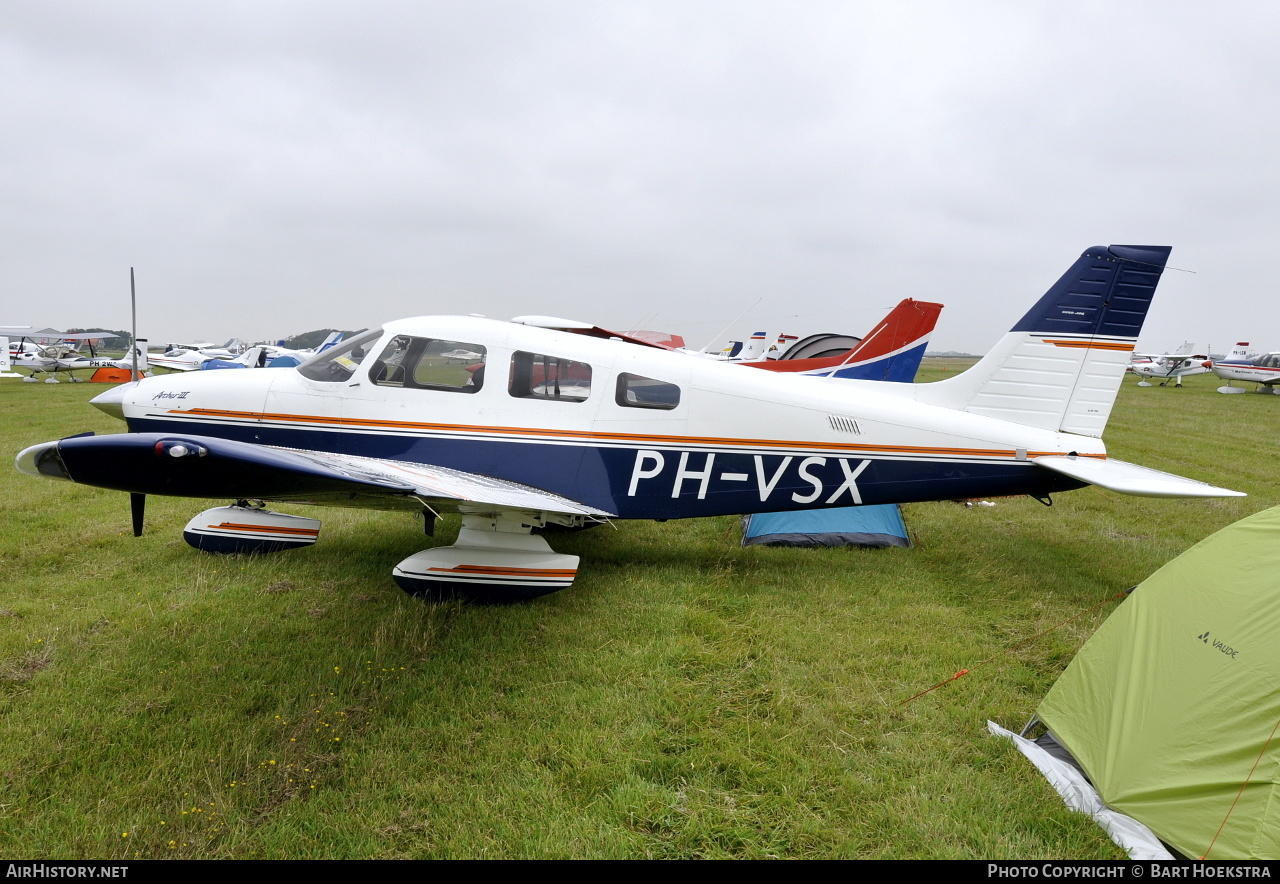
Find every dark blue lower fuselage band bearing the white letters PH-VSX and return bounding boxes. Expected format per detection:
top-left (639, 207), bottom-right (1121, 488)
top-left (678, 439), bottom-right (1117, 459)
top-left (129, 420), bottom-right (1084, 519)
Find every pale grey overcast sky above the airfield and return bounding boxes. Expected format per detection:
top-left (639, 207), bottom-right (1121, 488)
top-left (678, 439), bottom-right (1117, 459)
top-left (0, 0), bottom-right (1280, 352)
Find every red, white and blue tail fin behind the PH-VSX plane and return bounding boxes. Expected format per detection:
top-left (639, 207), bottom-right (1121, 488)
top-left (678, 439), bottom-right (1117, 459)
top-left (742, 298), bottom-right (942, 384)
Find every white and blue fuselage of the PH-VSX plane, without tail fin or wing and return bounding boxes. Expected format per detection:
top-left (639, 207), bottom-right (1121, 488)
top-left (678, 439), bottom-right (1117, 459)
top-left (97, 316), bottom-right (1106, 518)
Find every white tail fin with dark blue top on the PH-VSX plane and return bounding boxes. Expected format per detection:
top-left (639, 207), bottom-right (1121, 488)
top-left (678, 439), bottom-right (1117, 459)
top-left (916, 246), bottom-right (1172, 436)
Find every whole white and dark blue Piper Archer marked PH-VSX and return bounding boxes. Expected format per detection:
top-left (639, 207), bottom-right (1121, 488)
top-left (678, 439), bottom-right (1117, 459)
top-left (17, 246), bottom-right (1239, 600)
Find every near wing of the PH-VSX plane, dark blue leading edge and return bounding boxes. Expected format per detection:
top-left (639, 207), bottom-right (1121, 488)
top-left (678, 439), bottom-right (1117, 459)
top-left (17, 432), bottom-right (613, 517)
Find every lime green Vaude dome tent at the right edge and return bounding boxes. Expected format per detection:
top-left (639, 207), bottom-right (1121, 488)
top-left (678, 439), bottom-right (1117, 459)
top-left (998, 507), bottom-right (1280, 860)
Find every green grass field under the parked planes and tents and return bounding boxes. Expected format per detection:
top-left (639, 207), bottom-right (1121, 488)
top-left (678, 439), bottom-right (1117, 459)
top-left (0, 365), bottom-right (1280, 860)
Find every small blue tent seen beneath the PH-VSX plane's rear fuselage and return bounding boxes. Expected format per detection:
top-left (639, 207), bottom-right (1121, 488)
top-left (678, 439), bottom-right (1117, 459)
top-left (742, 504), bottom-right (911, 548)
